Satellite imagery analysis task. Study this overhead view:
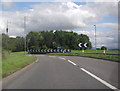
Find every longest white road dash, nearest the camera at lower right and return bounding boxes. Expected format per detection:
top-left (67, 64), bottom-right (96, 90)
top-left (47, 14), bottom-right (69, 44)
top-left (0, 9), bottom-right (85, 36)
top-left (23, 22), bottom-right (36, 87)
top-left (80, 68), bottom-right (117, 89)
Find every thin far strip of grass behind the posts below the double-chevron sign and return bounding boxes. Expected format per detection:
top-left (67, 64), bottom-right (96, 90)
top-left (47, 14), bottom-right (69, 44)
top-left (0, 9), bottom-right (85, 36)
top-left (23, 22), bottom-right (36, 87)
top-left (71, 50), bottom-right (120, 53)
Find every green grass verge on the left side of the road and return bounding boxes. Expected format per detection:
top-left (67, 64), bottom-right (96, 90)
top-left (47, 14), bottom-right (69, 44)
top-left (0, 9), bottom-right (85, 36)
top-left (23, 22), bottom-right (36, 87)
top-left (2, 52), bottom-right (36, 77)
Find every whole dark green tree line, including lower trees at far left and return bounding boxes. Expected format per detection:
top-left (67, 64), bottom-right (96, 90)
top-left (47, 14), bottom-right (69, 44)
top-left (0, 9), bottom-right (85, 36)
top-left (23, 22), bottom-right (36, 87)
top-left (2, 30), bottom-right (92, 51)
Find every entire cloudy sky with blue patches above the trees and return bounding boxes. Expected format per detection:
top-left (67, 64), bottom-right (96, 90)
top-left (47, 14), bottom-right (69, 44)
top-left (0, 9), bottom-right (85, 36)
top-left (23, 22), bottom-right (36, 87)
top-left (0, 0), bottom-right (118, 49)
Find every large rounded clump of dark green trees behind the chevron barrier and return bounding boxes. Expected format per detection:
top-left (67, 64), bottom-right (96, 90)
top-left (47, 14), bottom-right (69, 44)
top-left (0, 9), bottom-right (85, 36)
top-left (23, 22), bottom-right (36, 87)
top-left (26, 30), bottom-right (92, 49)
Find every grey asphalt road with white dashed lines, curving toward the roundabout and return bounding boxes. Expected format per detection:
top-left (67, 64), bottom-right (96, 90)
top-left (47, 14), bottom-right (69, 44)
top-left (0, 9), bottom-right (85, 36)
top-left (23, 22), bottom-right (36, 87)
top-left (3, 55), bottom-right (118, 89)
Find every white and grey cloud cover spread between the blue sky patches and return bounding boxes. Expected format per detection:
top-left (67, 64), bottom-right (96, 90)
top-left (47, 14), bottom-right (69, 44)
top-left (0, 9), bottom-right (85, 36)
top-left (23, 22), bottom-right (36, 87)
top-left (0, 2), bottom-right (118, 47)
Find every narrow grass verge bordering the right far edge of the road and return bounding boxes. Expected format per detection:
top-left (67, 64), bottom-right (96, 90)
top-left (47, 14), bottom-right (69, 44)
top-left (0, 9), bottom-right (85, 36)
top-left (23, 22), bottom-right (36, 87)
top-left (49, 53), bottom-right (120, 61)
